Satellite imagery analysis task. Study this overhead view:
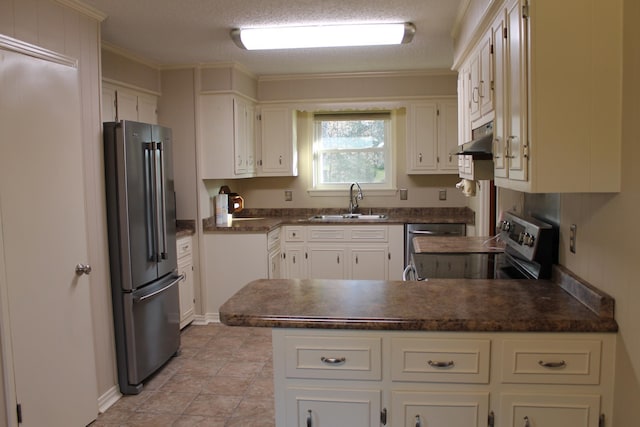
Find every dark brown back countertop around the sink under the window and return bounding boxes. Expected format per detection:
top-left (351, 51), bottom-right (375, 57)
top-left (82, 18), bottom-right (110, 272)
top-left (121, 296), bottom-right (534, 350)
top-left (202, 207), bottom-right (475, 233)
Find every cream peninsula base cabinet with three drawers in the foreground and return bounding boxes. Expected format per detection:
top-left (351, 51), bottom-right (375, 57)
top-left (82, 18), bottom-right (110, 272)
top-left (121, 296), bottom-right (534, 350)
top-left (273, 328), bottom-right (616, 427)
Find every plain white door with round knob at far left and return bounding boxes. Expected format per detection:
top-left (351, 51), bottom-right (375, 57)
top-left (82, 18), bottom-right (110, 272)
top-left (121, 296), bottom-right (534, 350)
top-left (0, 50), bottom-right (97, 427)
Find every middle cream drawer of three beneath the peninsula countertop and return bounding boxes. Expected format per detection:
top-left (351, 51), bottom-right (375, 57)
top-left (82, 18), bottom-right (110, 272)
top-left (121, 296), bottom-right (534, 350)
top-left (391, 338), bottom-right (491, 384)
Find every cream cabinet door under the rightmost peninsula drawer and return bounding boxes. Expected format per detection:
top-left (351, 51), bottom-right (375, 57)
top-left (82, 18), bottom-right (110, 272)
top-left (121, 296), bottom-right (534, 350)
top-left (500, 394), bottom-right (600, 427)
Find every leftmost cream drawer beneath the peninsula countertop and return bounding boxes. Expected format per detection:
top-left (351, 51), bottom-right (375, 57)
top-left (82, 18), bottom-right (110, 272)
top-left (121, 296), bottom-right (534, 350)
top-left (285, 336), bottom-right (382, 380)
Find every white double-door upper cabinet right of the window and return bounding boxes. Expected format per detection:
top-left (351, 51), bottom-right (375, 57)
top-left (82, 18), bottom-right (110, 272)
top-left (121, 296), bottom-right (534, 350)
top-left (407, 100), bottom-right (458, 174)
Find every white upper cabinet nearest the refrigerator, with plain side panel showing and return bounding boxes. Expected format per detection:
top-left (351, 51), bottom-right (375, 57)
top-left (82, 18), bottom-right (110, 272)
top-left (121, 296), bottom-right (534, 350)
top-left (198, 94), bottom-right (255, 179)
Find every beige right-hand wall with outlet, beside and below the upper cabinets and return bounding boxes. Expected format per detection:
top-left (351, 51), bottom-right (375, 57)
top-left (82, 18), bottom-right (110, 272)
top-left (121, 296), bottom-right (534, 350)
top-left (560, 0), bottom-right (640, 427)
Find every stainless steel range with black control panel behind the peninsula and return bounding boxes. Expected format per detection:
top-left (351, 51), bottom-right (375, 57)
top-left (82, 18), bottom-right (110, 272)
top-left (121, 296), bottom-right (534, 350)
top-left (403, 212), bottom-right (558, 280)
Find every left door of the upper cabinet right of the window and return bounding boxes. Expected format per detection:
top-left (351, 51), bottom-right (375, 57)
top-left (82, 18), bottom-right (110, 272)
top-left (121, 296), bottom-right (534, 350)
top-left (407, 102), bottom-right (438, 173)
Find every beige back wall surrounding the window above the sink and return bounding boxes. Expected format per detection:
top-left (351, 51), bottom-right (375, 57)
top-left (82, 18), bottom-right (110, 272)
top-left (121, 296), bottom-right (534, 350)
top-left (203, 70), bottom-right (468, 215)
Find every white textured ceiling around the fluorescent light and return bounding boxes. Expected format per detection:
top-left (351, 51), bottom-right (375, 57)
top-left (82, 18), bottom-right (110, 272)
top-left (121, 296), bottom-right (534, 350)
top-left (84, 0), bottom-right (464, 75)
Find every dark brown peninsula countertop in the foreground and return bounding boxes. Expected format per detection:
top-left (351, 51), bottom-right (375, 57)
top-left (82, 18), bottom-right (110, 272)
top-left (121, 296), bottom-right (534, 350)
top-left (220, 272), bottom-right (618, 332)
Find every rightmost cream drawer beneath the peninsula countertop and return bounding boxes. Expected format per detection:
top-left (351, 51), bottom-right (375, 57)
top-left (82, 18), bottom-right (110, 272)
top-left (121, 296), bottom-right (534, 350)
top-left (502, 340), bottom-right (602, 384)
